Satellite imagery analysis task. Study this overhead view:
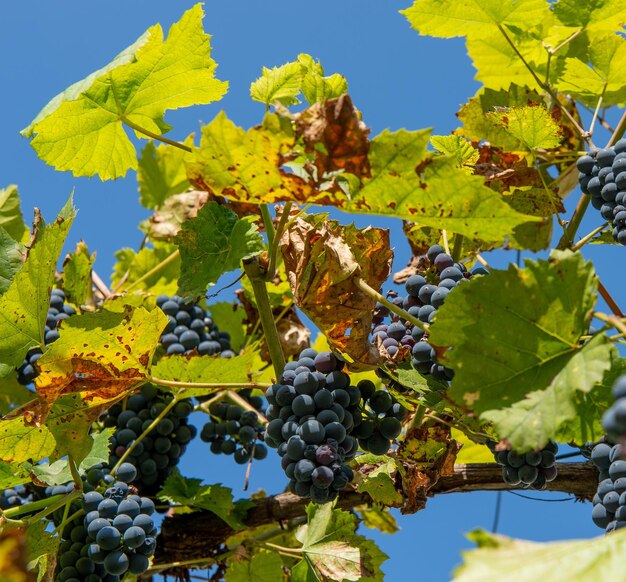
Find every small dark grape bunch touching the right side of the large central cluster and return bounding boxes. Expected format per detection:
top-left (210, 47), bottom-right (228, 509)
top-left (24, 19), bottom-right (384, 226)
top-left (354, 380), bottom-right (408, 455)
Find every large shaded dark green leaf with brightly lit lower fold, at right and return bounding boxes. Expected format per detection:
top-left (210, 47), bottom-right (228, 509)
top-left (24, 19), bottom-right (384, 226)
top-left (429, 252), bottom-right (600, 448)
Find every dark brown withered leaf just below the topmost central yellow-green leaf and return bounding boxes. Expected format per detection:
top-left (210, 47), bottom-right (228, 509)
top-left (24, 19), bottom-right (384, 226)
top-left (296, 95), bottom-right (370, 178)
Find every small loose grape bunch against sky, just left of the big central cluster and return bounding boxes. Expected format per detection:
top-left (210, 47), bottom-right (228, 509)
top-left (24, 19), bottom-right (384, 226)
top-left (200, 390), bottom-right (267, 465)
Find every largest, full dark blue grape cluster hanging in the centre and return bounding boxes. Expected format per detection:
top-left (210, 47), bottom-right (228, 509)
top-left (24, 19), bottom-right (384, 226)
top-left (265, 349), bottom-right (361, 503)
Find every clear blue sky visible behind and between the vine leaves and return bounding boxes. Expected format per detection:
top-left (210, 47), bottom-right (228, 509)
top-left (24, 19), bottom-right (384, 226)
top-left (0, 0), bottom-right (626, 582)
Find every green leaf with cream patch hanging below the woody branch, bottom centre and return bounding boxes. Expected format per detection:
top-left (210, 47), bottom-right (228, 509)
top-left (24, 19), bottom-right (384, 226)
top-left (292, 503), bottom-right (387, 582)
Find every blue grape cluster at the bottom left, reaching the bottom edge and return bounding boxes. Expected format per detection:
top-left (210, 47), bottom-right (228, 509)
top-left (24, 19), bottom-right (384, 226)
top-left (55, 463), bottom-right (156, 582)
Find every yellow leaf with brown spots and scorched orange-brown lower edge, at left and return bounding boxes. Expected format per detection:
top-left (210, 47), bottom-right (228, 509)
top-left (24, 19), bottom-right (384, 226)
top-left (35, 307), bottom-right (167, 403)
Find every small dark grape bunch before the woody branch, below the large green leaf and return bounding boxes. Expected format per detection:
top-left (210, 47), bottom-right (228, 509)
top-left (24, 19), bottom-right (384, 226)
top-left (487, 441), bottom-right (559, 490)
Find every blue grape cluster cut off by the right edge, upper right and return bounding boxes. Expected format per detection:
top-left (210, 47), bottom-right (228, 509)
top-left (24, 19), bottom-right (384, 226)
top-left (576, 139), bottom-right (626, 245)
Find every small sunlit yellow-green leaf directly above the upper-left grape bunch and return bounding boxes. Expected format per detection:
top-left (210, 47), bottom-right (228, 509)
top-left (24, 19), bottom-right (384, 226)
top-left (111, 242), bottom-right (180, 296)
